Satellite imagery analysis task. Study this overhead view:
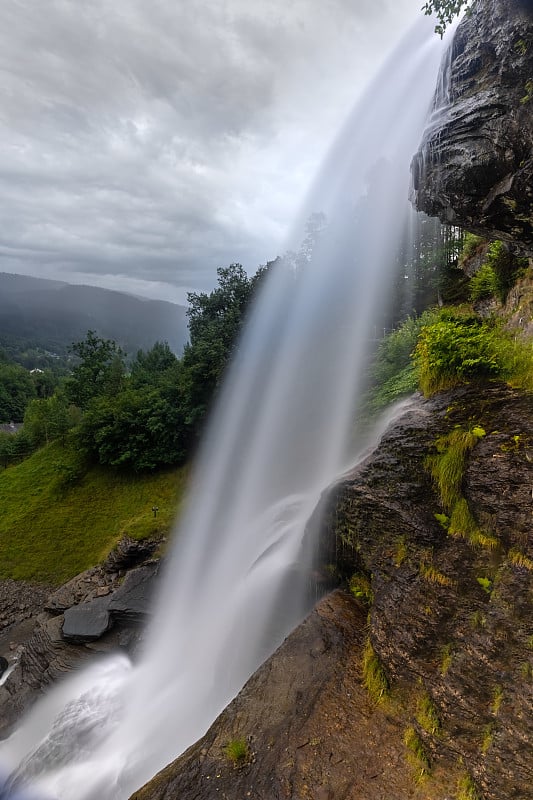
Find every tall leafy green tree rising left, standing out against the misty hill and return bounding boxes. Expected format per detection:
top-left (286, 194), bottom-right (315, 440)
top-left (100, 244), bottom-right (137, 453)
top-left (65, 330), bottom-right (125, 409)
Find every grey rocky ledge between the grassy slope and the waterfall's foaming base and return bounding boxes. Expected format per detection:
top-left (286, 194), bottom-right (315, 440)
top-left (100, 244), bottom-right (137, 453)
top-left (0, 537), bottom-right (159, 737)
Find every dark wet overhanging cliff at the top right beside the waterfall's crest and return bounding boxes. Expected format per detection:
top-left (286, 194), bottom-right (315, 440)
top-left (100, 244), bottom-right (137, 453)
top-left (412, 0), bottom-right (533, 255)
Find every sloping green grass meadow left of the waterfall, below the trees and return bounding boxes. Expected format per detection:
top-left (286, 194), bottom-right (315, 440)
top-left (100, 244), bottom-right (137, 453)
top-left (0, 443), bottom-right (186, 585)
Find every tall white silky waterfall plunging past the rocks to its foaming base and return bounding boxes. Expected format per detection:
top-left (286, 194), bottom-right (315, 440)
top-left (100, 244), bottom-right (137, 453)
top-left (0, 12), bottom-right (448, 800)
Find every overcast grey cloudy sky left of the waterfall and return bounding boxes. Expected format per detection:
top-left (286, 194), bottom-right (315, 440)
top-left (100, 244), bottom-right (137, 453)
top-left (0, 0), bottom-right (432, 302)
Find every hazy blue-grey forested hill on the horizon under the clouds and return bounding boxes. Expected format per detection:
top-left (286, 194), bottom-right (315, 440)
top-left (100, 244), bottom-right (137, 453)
top-left (0, 272), bottom-right (188, 355)
